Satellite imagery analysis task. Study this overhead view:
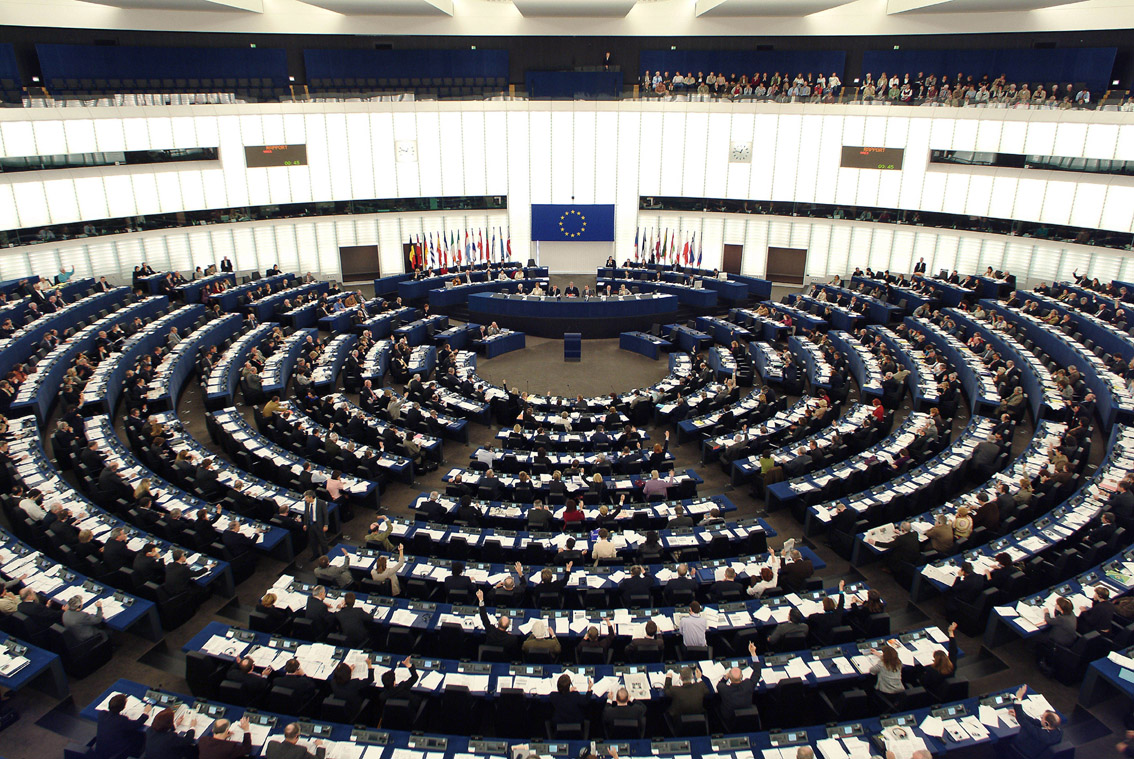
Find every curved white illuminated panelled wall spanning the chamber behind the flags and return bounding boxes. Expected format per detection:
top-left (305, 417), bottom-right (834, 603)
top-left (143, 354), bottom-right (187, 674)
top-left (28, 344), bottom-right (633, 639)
top-left (0, 102), bottom-right (1134, 282)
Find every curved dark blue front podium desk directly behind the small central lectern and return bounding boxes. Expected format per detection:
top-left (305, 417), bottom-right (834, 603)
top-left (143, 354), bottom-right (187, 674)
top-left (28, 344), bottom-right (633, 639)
top-left (468, 293), bottom-right (677, 337)
